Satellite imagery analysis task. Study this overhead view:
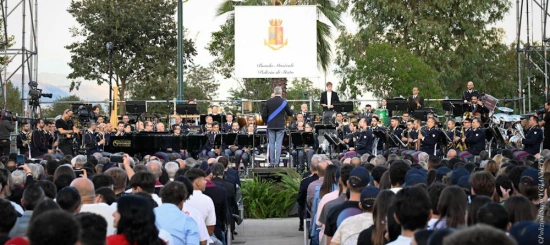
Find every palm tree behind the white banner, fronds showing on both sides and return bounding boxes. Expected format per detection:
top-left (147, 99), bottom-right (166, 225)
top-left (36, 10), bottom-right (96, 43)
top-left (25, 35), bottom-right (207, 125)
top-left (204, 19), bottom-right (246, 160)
top-left (206, 0), bottom-right (342, 97)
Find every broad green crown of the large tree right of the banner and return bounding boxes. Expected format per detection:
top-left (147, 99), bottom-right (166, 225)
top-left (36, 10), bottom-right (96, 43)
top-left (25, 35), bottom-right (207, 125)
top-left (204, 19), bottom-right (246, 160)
top-left (336, 0), bottom-right (514, 100)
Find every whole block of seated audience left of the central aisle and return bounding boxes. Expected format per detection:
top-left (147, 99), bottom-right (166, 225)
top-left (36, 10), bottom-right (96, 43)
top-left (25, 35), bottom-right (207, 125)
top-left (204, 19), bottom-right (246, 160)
top-left (0, 153), bottom-right (242, 245)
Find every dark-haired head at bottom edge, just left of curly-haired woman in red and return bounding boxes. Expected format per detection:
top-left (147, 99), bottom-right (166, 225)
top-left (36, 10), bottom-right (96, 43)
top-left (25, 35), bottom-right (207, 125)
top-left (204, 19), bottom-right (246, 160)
top-left (75, 212), bottom-right (107, 245)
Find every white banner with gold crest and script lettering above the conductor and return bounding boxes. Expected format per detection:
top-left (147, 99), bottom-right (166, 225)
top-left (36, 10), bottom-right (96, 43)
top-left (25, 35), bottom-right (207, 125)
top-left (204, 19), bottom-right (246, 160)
top-left (235, 6), bottom-right (319, 78)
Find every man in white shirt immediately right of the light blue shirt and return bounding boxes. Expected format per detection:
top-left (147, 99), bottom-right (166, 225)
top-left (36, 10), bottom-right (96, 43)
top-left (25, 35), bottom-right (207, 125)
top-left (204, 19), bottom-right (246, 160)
top-left (185, 168), bottom-right (216, 236)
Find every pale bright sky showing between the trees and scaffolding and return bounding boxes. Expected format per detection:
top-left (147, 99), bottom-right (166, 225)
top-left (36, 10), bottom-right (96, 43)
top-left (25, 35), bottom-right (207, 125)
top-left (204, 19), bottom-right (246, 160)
top-left (7, 0), bottom-right (542, 104)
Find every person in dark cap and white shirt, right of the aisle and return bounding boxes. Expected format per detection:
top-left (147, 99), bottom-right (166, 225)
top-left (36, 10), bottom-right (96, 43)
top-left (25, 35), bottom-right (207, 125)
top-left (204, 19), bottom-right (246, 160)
top-left (330, 185), bottom-right (380, 245)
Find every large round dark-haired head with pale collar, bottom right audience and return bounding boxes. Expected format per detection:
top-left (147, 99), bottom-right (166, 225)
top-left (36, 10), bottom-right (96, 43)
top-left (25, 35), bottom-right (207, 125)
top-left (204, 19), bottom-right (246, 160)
top-left (387, 186), bottom-right (432, 245)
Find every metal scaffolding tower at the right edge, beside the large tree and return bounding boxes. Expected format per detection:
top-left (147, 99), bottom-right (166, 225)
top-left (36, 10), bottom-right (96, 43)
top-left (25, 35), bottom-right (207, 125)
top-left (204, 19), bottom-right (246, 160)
top-left (516, 0), bottom-right (550, 114)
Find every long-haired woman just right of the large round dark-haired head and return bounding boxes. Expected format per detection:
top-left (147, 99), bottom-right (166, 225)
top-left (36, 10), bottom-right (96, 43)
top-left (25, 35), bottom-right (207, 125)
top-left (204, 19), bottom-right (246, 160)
top-left (434, 186), bottom-right (468, 230)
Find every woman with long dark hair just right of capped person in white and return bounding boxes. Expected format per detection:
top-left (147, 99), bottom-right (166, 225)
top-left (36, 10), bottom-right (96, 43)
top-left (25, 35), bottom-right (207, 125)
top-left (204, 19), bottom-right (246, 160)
top-left (357, 190), bottom-right (395, 245)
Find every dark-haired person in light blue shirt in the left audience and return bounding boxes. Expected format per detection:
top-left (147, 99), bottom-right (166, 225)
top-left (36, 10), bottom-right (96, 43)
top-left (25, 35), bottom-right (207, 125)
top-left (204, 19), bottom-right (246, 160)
top-left (155, 182), bottom-right (199, 245)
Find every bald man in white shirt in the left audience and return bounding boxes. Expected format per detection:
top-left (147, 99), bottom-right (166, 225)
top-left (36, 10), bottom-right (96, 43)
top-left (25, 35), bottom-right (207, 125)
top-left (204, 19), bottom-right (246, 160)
top-left (71, 178), bottom-right (116, 236)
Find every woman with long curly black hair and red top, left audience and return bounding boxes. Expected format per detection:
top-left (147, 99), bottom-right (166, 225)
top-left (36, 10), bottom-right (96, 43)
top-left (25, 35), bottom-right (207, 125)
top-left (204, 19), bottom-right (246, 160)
top-left (107, 195), bottom-right (165, 245)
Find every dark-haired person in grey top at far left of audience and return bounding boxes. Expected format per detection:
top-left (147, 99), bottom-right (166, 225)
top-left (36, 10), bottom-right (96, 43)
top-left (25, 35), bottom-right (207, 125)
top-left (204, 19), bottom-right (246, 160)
top-left (9, 184), bottom-right (45, 237)
